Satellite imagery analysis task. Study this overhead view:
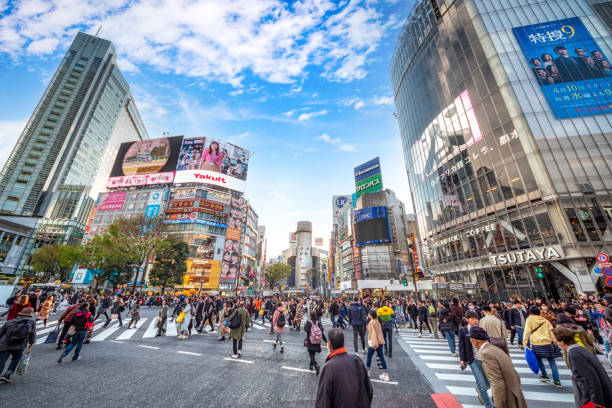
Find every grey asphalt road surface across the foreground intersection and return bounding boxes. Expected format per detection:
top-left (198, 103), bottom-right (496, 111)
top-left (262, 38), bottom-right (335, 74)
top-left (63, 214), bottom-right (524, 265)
top-left (0, 308), bottom-right (435, 408)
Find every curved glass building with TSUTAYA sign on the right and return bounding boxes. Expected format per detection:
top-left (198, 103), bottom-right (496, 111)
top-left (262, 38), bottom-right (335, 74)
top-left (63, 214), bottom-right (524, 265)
top-left (391, 0), bottom-right (612, 300)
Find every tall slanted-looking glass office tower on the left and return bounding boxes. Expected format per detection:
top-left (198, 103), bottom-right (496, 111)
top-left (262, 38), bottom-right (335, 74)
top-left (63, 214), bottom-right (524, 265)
top-left (0, 33), bottom-right (148, 284)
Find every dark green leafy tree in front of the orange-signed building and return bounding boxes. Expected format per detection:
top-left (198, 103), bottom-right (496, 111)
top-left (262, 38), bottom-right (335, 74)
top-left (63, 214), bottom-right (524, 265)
top-left (149, 236), bottom-right (189, 294)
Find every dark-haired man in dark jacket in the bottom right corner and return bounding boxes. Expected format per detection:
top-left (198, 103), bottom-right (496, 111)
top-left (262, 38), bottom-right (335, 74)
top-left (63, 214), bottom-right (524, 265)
top-left (553, 327), bottom-right (612, 408)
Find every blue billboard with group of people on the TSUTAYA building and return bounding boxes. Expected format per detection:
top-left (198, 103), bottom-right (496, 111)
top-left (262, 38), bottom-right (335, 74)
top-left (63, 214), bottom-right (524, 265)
top-left (512, 17), bottom-right (612, 119)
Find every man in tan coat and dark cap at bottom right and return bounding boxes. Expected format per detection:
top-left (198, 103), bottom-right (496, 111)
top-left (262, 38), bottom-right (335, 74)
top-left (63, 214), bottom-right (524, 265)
top-left (470, 326), bottom-right (527, 408)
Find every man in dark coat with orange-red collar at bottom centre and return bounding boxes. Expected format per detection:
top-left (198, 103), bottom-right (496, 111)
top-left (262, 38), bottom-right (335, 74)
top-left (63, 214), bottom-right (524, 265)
top-left (315, 329), bottom-right (374, 408)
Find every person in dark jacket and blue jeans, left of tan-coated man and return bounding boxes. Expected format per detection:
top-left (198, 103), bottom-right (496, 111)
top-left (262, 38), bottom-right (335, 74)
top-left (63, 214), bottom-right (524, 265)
top-left (459, 310), bottom-right (493, 408)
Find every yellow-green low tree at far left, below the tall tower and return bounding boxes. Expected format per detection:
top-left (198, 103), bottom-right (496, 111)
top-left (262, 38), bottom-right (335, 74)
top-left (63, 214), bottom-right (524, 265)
top-left (32, 244), bottom-right (86, 283)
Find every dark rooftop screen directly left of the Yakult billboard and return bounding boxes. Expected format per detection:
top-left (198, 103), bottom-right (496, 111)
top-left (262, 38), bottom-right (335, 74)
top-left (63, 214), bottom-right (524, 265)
top-left (106, 136), bottom-right (183, 188)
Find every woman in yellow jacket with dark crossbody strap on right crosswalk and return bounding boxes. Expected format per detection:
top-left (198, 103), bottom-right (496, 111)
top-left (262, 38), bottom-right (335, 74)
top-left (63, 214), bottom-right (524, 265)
top-left (523, 305), bottom-right (563, 388)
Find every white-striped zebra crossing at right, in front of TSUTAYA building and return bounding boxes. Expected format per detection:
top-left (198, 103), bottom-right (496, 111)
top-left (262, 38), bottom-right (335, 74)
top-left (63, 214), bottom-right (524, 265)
top-left (399, 330), bottom-right (574, 408)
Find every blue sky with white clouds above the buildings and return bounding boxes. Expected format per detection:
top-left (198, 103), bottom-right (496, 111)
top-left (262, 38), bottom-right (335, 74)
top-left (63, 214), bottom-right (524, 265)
top-left (0, 0), bottom-right (413, 257)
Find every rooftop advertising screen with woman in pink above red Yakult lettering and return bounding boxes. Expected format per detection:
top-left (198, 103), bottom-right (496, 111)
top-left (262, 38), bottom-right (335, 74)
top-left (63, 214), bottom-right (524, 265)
top-left (174, 137), bottom-right (249, 192)
